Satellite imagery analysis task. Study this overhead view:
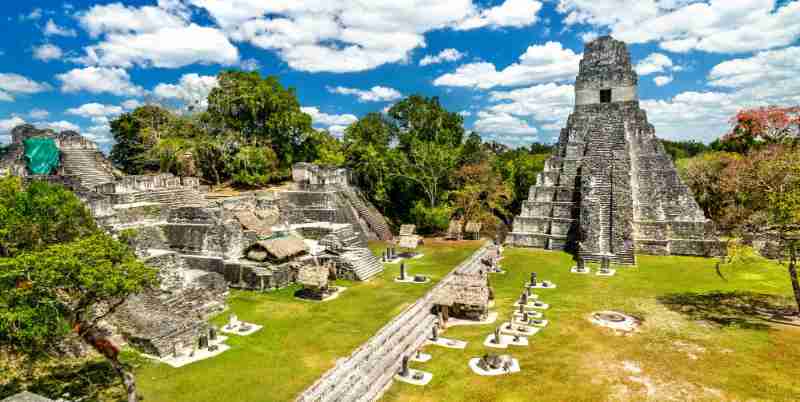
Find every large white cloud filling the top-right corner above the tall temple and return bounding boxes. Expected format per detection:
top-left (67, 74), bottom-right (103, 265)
top-left (557, 0), bottom-right (800, 53)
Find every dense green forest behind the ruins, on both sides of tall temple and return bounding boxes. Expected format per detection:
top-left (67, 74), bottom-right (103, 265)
top-left (106, 71), bottom-right (800, 240)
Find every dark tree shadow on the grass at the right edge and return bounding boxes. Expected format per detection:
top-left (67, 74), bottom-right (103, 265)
top-left (657, 292), bottom-right (800, 330)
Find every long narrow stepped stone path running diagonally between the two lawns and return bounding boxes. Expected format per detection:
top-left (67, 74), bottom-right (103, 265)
top-left (296, 242), bottom-right (495, 402)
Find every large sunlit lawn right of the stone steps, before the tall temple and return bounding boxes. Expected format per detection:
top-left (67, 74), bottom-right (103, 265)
top-left (384, 249), bottom-right (800, 401)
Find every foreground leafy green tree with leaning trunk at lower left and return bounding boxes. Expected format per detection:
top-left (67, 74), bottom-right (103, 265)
top-left (0, 234), bottom-right (156, 402)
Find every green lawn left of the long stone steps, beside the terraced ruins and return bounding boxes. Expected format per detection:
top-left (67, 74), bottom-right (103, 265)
top-left (136, 240), bottom-right (482, 402)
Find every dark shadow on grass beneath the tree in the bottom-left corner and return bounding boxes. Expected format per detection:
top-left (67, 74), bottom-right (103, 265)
top-left (0, 361), bottom-right (123, 402)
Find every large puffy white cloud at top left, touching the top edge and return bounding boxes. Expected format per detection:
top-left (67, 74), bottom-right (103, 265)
top-left (77, 0), bottom-right (239, 68)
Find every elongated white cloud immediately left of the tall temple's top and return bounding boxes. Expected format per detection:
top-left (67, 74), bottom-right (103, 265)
top-left (433, 42), bottom-right (582, 89)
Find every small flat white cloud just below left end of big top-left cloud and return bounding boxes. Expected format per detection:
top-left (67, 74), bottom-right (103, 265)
top-left (56, 67), bottom-right (144, 96)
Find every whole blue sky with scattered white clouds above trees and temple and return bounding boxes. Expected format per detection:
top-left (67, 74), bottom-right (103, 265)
top-left (0, 0), bottom-right (800, 150)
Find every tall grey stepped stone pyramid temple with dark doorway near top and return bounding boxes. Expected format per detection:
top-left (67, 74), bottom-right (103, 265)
top-left (508, 36), bottom-right (720, 264)
